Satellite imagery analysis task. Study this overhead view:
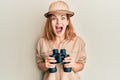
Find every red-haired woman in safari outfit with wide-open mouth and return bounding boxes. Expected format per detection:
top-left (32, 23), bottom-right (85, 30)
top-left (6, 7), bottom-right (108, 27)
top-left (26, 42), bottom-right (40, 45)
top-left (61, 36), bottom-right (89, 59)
top-left (37, 1), bottom-right (86, 80)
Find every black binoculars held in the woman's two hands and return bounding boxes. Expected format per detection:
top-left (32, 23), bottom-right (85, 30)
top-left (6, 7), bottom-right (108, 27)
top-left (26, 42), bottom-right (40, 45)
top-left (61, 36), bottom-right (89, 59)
top-left (48, 49), bottom-right (72, 73)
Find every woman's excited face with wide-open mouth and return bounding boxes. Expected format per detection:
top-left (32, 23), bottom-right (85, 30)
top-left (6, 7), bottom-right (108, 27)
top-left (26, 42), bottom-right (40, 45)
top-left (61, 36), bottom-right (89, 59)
top-left (51, 13), bottom-right (69, 37)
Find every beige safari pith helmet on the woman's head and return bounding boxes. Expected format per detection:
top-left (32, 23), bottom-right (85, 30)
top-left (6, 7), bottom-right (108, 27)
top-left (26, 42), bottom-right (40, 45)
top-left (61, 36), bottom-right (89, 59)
top-left (44, 1), bottom-right (74, 18)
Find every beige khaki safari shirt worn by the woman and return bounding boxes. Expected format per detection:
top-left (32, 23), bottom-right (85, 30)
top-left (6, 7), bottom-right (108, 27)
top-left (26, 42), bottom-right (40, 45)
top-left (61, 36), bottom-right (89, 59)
top-left (37, 36), bottom-right (86, 80)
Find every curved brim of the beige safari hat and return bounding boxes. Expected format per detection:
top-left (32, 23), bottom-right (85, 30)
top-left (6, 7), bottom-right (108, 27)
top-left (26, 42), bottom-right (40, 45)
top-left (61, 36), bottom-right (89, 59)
top-left (44, 10), bottom-right (74, 18)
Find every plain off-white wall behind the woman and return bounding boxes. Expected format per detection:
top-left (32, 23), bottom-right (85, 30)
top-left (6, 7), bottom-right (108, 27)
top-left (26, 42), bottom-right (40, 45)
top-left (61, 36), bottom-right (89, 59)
top-left (0, 0), bottom-right (120, 80)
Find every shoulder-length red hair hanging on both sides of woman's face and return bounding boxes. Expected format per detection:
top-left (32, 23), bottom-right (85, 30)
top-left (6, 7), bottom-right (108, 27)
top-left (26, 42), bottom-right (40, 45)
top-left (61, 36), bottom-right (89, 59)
top-left (43, 15), bottom-right (76, 41)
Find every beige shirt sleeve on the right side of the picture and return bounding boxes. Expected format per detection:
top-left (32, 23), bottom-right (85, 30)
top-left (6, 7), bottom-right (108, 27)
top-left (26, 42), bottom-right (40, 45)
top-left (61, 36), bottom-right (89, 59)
top-left (76, 39), bottom-right (86, 63)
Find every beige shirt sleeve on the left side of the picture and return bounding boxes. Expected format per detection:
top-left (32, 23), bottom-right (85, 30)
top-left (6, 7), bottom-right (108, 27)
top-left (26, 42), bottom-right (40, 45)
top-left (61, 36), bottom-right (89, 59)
top-left (36, 39), bottom-right (44, 63)
